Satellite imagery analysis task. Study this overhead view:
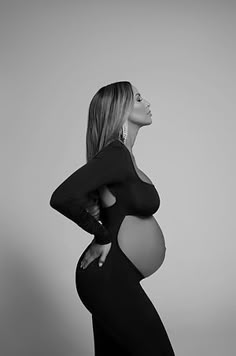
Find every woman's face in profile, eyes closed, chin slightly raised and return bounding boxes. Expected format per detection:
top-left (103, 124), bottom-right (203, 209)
top-left (129, 85), bottom-right (152, 126)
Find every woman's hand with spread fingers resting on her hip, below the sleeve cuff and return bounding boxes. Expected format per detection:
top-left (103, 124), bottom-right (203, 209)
top-left (80, 239), bottom-right (111, 269)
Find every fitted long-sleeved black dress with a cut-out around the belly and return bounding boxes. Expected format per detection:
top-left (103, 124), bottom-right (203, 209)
top-left (50, 139), bottom-right (174, 356)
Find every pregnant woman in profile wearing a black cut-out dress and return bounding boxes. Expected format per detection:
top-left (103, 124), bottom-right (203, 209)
top-left (50, 81), bottom-right (175, 356)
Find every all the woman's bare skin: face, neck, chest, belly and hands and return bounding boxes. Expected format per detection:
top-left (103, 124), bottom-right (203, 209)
top-left (81, 86), bottom-right (166, 277)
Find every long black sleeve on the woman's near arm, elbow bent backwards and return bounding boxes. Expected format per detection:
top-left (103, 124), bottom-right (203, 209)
top-left (49, 142), bottom-right (127, 245)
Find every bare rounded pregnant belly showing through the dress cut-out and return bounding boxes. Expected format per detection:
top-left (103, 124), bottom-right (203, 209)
top-left (117, 215), bottom-right (166, 277)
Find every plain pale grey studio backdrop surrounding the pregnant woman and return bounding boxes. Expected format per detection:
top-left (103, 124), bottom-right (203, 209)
top-left (0, 0), bottom-right (236, 356)
